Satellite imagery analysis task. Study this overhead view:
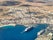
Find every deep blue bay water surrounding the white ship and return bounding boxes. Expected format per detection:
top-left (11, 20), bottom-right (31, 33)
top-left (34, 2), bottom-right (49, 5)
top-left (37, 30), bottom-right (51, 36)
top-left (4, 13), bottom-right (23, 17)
top-left (0, 24), bottom-right (48, 40)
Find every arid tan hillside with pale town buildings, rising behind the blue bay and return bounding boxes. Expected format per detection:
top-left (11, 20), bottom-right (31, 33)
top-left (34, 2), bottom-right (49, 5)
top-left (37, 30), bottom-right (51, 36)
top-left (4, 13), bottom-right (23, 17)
top-left (0, 0), bottom-right (53, 25)
